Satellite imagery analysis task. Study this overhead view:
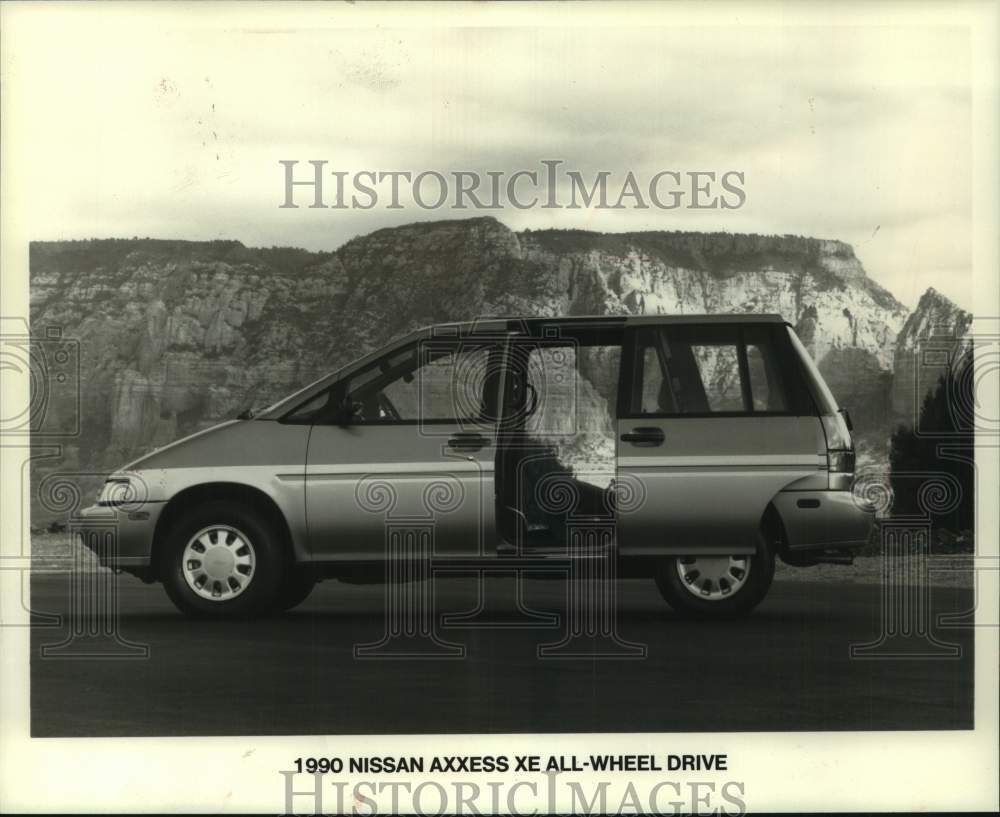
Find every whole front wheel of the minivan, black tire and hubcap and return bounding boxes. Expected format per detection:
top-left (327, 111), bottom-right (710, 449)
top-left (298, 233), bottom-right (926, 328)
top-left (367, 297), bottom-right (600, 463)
top-left (160, 501), bottom-right (285, 619)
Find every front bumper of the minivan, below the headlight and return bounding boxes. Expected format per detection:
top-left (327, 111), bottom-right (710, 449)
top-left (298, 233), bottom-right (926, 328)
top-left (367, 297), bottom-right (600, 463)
top-left (72, 502), bottom-right (166, 573)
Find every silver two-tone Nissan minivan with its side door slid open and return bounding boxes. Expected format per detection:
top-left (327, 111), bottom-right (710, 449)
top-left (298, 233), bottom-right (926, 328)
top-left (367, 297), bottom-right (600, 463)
top-left (80, 315), bottom-right (872, 617)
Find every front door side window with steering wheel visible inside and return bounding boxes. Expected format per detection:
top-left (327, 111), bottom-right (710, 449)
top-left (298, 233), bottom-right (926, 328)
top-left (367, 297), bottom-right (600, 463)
top-left (346, 339), bottom-right (495, 424)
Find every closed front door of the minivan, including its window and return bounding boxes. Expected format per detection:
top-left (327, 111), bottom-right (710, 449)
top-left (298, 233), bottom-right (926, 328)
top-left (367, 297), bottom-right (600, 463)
top-left (296, 335), bottom-right (502, 560)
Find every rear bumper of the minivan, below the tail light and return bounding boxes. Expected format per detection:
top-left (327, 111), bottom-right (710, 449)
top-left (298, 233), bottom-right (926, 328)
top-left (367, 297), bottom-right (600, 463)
top-left (774, 491), bottom-right (875, 551)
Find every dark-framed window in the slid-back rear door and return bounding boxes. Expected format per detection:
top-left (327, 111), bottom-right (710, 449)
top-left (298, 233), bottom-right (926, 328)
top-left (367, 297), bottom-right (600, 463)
top-left (626, 324), bottom-right (816, 418)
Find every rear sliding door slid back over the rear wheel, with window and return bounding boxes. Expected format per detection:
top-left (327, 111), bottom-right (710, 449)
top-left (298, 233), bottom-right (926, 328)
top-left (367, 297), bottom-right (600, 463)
top-left (617, 323), bottom-right (826, 555)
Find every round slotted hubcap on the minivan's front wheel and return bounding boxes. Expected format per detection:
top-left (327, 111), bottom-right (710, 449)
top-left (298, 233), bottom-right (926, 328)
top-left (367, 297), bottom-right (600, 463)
top-left (183, 525), bottom-right (257, 601)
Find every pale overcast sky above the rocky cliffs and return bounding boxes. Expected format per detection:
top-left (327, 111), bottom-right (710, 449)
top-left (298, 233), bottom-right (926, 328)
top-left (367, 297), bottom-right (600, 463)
top-left (4, 4), bottom-right (972, 309)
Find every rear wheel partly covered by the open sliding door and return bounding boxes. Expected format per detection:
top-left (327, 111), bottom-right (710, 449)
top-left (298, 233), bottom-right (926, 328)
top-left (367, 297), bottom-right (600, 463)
top-left (656, 543), bottom-right (774, 619)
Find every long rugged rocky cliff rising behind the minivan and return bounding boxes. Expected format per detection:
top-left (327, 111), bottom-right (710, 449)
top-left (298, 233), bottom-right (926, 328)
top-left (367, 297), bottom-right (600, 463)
top-left (25, 218), bottom-right (968, 524)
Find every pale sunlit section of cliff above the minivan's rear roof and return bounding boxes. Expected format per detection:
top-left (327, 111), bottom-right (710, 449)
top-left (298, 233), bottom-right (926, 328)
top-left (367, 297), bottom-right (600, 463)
top-left (520, 231), bottom-right (906, 367)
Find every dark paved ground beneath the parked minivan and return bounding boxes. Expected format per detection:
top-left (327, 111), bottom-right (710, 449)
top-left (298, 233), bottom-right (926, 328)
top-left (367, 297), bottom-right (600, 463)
top-left (31, 574), bottom-right (973, 736)
